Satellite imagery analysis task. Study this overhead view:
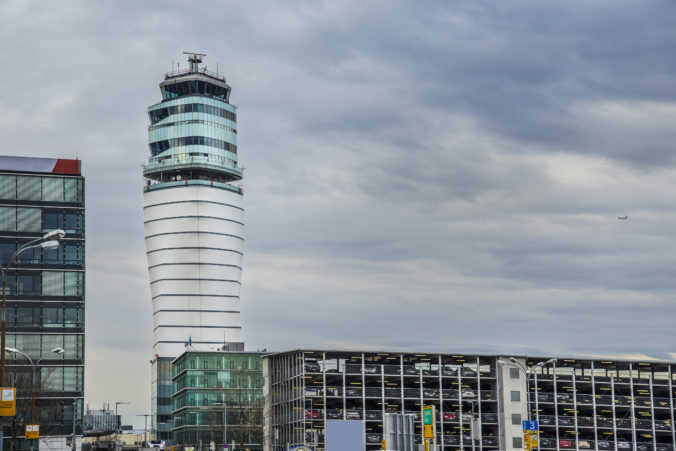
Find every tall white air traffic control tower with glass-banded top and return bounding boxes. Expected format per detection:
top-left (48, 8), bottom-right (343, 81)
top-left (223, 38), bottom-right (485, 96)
top-left (143, 53), bottom-right (244, 438)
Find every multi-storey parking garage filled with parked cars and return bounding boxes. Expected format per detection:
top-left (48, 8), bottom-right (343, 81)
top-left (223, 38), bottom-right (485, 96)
top-left (264, 350), bottom-right (676, 451)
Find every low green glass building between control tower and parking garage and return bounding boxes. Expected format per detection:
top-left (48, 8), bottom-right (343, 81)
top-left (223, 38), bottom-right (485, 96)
top-left (172, 351), bottom-right (263, 451)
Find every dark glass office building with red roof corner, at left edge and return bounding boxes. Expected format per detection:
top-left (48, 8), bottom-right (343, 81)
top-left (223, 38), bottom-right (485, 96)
top-left (0, 156), bottom-right (85, 449)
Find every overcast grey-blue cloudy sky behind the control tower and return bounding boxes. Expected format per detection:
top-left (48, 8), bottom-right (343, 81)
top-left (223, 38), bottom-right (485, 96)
top-left (0, 0), bottom-right (676, 426)
